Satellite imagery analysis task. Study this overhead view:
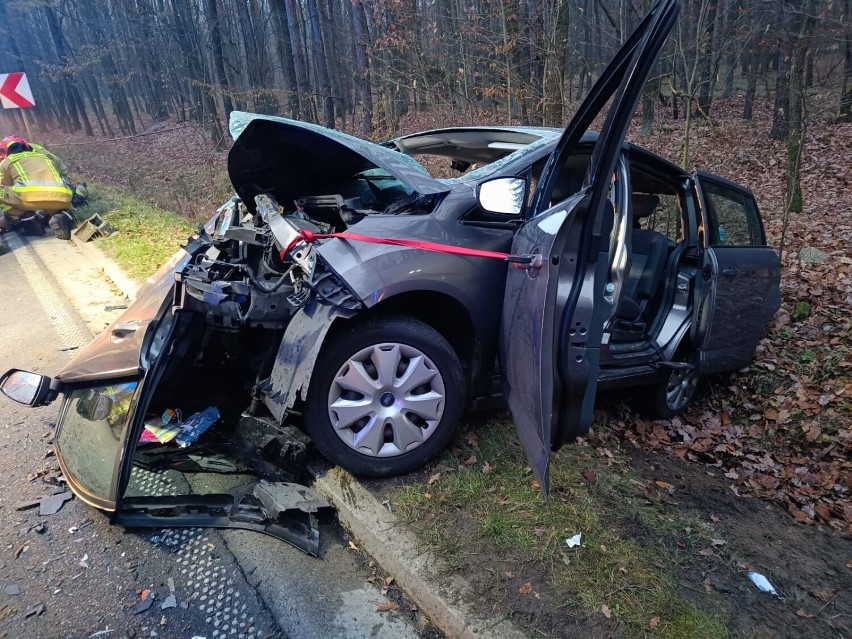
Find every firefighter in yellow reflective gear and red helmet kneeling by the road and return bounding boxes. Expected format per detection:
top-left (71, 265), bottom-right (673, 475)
top-left (0, 136), bottom-right (73, 240)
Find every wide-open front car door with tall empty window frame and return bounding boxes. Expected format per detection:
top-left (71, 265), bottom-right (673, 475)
top-left (500, 0), bottom-right (679, 492)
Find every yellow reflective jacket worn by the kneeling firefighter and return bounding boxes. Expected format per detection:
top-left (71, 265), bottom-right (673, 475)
top-left (0, 151), bottom-right (72, 211)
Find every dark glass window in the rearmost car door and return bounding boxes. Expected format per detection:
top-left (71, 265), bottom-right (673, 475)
top-left (702, 181), bottom-right (766, 246)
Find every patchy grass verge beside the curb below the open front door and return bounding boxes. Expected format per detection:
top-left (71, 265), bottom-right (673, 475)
top-left (392, 419), bottom-right (730, 639)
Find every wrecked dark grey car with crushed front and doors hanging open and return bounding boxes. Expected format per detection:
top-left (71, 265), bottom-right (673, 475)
top-left (2, 0), bottom-right (780, 541)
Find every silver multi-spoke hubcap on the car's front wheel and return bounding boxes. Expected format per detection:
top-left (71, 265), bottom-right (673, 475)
top-left (328, 343), bottom-right (446, 457)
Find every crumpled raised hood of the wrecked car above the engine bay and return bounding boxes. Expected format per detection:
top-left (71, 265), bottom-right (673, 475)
top-left (228, 111), bottom-right (450, 208)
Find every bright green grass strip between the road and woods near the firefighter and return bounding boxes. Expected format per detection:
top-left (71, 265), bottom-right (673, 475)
top-left (76, 184), bottom-right (197, 282)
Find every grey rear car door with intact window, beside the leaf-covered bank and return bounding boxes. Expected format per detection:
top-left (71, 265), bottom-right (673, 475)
top-left (693, 171), bottom-right (781, 374)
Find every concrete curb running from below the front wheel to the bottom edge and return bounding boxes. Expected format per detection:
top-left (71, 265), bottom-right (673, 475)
top-left (309, 467), bottom-right (528, 639)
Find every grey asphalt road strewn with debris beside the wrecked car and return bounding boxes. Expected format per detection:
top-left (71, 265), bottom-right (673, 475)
top-left (0, 235), bottom-right (426, 639)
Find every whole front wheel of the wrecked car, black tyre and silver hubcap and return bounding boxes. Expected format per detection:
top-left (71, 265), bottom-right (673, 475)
top-left (305, 315), bottom-right (465, 477)
